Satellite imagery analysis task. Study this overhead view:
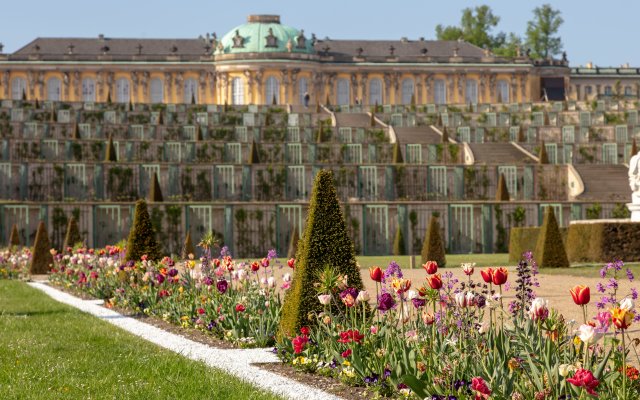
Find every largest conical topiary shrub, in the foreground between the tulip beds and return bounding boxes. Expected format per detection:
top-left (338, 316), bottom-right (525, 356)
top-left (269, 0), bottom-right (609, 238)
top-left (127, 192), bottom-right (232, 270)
top-left (279, 170), bottom-right (362, 337)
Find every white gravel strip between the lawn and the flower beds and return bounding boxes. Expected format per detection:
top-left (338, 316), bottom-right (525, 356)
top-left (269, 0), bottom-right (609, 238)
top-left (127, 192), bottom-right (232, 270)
top-left (29, 282), bottom-right (341, 400)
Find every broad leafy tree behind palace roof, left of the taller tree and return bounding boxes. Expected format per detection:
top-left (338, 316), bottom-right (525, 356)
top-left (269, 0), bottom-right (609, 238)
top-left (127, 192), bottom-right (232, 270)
top-left (436, 5), bottom-right (505, 49)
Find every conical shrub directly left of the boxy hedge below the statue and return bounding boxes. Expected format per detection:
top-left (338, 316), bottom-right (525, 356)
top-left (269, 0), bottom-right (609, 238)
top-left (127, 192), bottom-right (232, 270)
top-left (534, 207), bottom-right (569, 268)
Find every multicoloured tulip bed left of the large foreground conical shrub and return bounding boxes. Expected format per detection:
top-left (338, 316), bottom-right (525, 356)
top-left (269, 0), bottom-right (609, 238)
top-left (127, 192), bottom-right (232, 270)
top-left (49, 246), bottom-right (290, 347)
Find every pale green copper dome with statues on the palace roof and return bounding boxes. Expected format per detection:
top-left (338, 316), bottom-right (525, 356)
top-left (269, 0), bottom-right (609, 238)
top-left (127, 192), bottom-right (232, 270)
top-left (217, 15), bottom-right (314, 54)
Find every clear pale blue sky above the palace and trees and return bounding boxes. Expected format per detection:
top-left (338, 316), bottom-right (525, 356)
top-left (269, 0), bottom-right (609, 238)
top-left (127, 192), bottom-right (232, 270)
top-left (0, 0), bottom-right (640, 67)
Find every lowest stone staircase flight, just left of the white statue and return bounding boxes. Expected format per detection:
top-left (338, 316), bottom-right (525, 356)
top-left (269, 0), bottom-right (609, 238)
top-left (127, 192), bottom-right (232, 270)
top-left (573, 164), bottom-right (631, 203)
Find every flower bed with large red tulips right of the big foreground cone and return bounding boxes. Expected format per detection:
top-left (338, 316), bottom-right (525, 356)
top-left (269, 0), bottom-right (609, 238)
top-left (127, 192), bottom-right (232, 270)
top-left (277, 254), bottom-right (640, 400)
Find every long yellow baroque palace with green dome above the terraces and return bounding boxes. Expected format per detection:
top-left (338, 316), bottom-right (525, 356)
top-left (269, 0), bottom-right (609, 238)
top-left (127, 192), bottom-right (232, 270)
top-left (0, 15), bottom-right (575, 105)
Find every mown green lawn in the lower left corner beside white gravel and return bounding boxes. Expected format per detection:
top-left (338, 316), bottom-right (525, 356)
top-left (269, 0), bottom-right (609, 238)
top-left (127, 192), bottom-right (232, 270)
top-left (0, 280), bottom-right (278, 400)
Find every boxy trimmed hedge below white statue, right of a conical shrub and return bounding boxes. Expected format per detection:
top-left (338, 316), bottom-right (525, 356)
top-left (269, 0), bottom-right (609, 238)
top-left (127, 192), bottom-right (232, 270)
top-left (567, 222), bottom-right (640, 262)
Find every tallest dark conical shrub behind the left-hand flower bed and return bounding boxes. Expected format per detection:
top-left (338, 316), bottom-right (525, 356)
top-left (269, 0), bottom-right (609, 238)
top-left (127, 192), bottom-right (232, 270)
top-left (126, 200), bottom-right (162, 261)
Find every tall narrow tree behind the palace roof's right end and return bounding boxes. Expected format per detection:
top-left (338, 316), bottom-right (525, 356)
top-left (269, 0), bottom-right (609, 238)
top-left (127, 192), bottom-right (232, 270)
top-left (526, 4), bottom-right (564, 58)
